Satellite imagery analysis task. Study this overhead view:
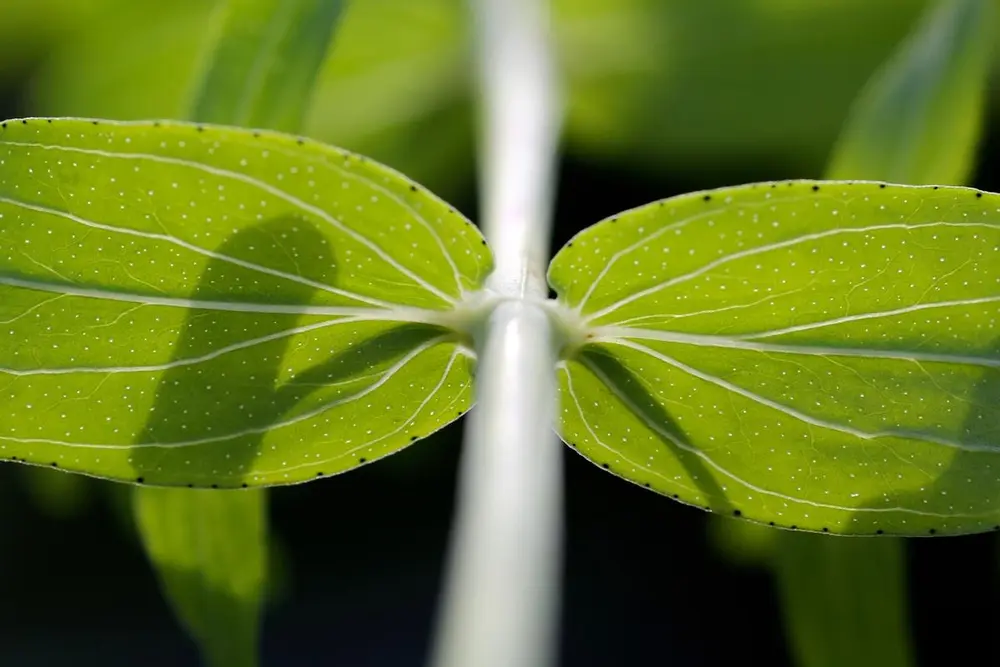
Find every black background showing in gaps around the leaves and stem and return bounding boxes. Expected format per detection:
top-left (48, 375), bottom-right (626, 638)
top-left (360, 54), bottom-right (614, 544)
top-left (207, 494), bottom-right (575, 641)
top-left (0, 1), bottom-right (1000, 667)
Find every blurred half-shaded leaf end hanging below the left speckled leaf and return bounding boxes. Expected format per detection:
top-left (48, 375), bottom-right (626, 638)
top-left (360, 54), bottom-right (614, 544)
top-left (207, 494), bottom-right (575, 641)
top-left (135, 489), bottom-right (267, 667)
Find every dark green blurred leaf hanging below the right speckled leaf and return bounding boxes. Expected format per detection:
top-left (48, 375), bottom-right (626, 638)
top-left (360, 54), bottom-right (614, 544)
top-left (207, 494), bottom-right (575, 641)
top-left (774, 534), bottom-right (914, 667)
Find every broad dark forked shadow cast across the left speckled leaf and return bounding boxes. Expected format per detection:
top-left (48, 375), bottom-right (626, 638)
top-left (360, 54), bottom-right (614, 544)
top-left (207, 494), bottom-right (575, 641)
top-left (131, 219), bottom-right (441, 487)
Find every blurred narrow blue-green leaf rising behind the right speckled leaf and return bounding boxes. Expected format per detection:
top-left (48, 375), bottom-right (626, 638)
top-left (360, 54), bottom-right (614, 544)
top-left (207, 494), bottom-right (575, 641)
top-left (827, 0), bottom-right (996, 185)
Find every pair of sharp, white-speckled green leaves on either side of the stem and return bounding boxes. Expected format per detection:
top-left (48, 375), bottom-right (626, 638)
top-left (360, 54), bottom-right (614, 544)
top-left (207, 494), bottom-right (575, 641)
top-left (0, 119), bottom-right (1000, 534)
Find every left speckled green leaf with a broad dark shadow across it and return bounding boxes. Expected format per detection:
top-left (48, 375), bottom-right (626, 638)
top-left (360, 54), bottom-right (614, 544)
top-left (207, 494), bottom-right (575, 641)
top-left (0, 119), bottom-right (491, 488)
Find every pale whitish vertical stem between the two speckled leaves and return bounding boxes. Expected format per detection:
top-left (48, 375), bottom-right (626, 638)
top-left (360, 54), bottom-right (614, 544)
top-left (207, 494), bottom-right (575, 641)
top-left (432, 0), bottom-right (562, 667)
